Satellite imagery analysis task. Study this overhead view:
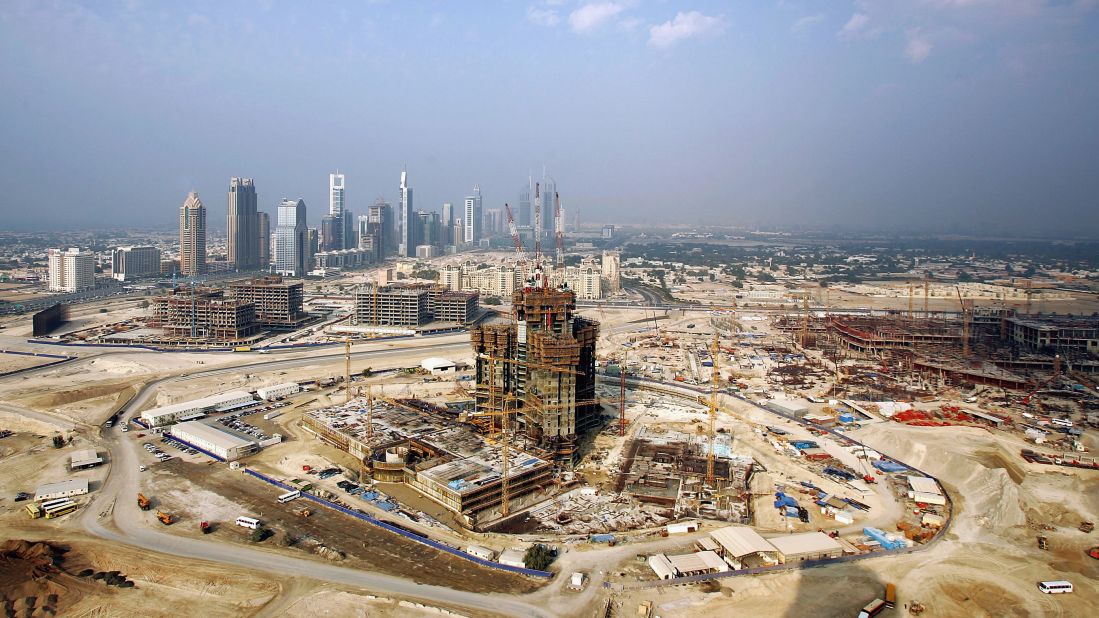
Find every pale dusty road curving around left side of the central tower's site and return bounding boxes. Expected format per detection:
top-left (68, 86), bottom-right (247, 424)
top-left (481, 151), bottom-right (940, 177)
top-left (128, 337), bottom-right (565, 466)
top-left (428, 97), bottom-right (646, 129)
top-left (70, 343), bottom-right (554, 617)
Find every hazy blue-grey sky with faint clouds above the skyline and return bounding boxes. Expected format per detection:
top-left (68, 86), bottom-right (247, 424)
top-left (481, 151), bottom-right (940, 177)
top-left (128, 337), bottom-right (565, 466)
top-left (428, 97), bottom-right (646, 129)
top-left (0, 0), bottom-right (1099, 235)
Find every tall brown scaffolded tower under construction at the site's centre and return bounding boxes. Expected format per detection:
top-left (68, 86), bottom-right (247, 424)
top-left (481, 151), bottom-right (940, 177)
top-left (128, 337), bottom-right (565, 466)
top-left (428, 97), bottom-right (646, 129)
top-left (471, 274), bottom-right (600, 465)
